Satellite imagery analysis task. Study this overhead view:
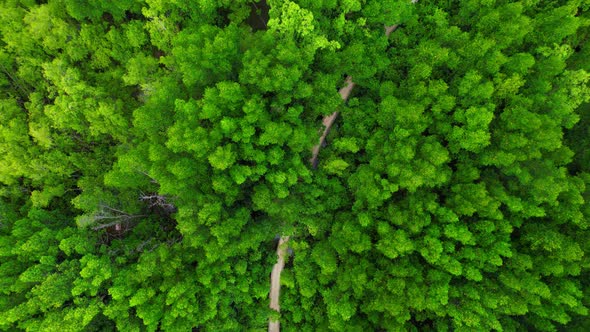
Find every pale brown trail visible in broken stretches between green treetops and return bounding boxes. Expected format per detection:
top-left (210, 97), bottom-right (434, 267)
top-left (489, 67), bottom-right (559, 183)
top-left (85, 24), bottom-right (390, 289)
top-left (268, 18), bottom-right (408, 332)
